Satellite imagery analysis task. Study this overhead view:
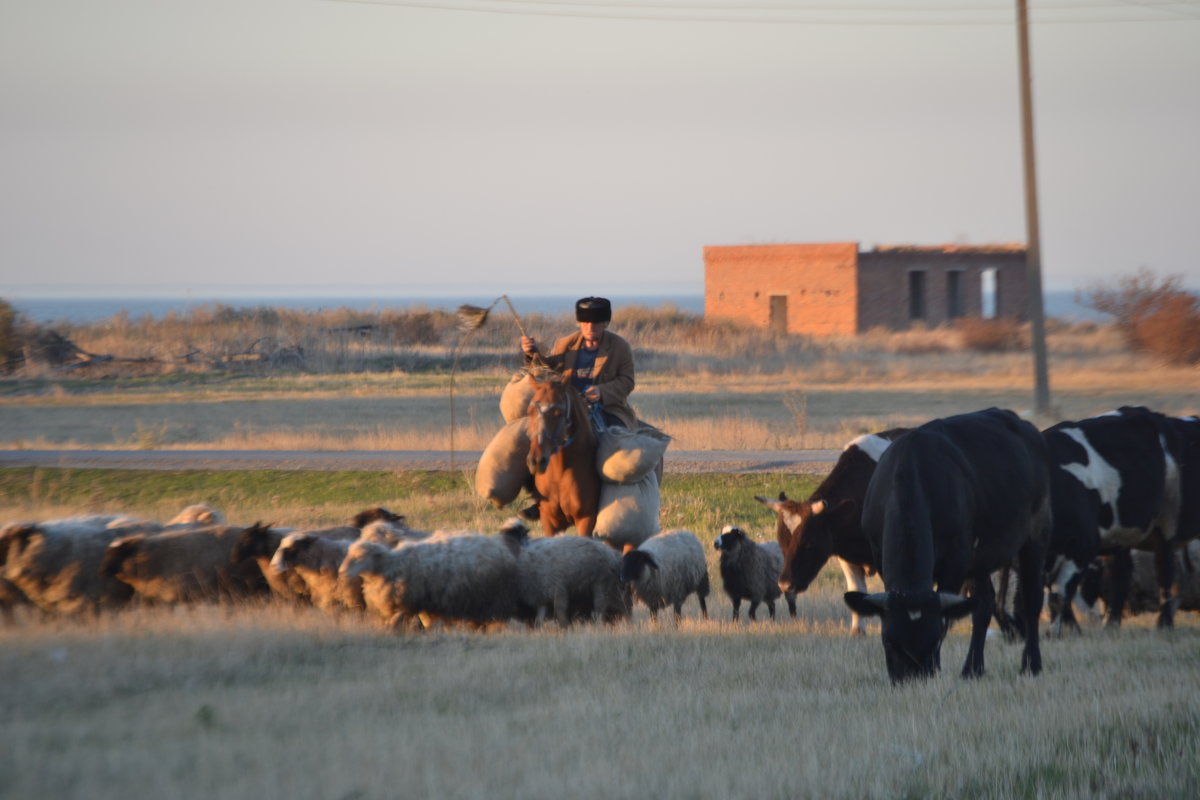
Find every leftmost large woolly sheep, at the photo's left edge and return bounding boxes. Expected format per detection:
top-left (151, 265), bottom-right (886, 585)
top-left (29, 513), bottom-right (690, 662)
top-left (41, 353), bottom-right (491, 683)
top-left (0, 515), bottom-right (157, 614)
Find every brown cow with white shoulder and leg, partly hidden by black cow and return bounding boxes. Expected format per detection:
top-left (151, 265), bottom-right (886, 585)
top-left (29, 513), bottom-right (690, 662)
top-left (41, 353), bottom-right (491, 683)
top-left (755, 428), bottom-right (908, 636)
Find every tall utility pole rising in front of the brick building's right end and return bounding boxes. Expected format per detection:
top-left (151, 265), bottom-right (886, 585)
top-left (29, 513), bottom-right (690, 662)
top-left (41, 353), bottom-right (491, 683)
top-left (1016, 0), bottom-right (1050, 416)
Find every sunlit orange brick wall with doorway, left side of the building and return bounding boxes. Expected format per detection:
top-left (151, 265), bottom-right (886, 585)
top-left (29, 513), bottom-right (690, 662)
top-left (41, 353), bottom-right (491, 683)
top-left (704, 242), bottom-right (858, 336)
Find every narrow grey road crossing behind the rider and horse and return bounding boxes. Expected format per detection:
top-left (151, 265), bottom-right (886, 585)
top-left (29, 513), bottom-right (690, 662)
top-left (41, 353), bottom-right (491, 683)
top-left (0, 450), bottom-right (839, 474)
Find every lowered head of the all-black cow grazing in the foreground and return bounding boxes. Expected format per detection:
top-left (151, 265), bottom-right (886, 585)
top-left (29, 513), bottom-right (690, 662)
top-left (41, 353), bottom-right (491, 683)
top-left (845, 591), bottom-right (974, 684)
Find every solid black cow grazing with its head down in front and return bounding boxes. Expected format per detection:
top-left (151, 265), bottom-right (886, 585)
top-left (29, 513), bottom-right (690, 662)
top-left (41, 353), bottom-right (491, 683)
top-left (845, 408), bottom-right (1050, 684)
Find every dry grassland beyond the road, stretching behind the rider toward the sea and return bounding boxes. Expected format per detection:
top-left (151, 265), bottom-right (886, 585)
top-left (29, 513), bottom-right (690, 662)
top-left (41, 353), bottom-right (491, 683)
top-left (0, 312), bottom-right (1200, 450)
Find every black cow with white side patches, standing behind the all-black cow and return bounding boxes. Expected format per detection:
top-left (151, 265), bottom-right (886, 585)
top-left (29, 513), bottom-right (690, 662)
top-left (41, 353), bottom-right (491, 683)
top-left (1042, 407), bottom-right (1180, 632)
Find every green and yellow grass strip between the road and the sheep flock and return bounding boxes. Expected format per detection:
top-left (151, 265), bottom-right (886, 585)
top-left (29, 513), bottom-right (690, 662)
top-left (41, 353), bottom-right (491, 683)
top-left (0, 468), bottom-right (822, 539)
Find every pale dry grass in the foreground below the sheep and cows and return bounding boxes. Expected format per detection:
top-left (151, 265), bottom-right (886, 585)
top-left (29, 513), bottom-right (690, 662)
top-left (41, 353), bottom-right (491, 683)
top-left (0, 590), bottom-right (1200, 800)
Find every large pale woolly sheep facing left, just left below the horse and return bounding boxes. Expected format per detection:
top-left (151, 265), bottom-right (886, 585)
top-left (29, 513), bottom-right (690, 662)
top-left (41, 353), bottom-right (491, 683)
top-left (340, 534), bottom-right (517, 627)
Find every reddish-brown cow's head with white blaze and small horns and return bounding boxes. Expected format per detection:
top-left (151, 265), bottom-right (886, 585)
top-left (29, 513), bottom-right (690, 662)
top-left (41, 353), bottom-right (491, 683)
top-left (755, 492), bottom-right (858, 591)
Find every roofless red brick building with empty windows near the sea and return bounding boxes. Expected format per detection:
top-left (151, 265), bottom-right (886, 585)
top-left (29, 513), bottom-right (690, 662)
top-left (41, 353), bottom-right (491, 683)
top-left (704, 242), bottom-right (1026, 336)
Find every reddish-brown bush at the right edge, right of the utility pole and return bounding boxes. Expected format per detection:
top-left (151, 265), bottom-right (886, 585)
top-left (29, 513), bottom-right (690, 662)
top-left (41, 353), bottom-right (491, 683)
top-left (1081, 267), bottom-right (1200, 363)
